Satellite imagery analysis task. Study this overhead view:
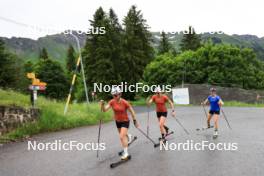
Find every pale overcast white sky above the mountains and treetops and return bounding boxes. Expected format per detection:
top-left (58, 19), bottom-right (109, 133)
top-left (0, 0), bottom-right (264, 39)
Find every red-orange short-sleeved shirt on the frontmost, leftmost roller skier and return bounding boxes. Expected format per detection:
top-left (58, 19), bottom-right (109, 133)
top-left (109, 98), bottom-right (131, 122)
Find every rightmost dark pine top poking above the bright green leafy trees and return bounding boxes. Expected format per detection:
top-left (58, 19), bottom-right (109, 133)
top-left (180, 26), bottom-right (201, 52)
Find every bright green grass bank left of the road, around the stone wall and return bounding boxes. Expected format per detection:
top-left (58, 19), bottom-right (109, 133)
top-left (0, 89), bottom-right (112, 142)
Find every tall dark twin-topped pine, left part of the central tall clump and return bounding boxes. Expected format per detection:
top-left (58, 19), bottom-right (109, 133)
top-left (83, 7), bottom-right (120, 97)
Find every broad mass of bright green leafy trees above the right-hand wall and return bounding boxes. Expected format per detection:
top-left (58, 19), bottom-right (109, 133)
top-left (144, 43), bottom-right (264, 89)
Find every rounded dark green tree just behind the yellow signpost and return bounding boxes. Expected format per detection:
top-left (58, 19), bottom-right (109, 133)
top-left (36, 59), bottom-right (69, 99)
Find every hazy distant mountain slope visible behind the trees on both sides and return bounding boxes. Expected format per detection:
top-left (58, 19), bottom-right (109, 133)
top-left (0, 32), bottom-right (264, 64)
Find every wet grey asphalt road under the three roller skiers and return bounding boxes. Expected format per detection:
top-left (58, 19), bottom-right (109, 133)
top-left (0, 107), bottom-right (264, 176)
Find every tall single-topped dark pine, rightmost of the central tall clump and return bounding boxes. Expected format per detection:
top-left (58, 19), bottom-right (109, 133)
top-left (123, 6), bottom-right (153, 99)
